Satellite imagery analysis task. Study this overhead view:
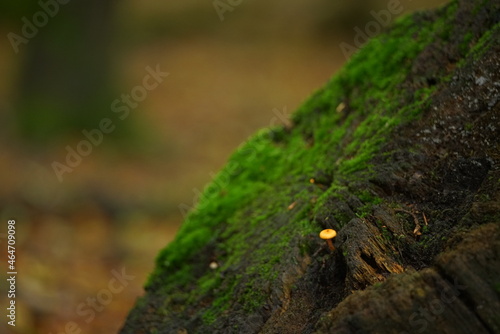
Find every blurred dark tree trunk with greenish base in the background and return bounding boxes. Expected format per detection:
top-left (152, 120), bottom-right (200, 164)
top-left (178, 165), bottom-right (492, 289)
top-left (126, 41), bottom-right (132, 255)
top-left (10, 0), bottom-right (113, 142)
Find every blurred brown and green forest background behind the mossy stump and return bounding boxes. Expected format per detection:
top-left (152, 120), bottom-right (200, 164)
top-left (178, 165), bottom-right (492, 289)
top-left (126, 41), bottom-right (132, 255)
top-left (0, 0), bottom-right (445, 334)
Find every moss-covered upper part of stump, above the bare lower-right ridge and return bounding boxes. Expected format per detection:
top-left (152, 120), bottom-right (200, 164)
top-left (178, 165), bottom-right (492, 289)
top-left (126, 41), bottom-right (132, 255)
top-left (122, 1), bottom-right (499, 333)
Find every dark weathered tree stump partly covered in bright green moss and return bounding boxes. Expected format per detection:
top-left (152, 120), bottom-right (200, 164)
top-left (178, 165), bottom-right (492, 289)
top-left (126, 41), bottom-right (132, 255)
top-left (122, 0), bottom-right (500, 334)
